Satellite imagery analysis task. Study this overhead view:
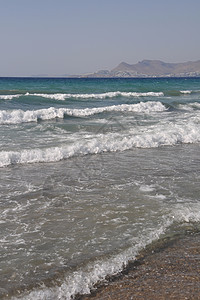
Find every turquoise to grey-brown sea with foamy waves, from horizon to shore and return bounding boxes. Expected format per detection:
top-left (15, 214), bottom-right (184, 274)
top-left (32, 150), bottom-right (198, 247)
top-left (0, 78), bottom-right (200, 300)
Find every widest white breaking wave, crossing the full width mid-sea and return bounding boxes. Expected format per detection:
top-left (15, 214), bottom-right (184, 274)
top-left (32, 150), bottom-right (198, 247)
top-left (0, 122), bottom-right (200, 167)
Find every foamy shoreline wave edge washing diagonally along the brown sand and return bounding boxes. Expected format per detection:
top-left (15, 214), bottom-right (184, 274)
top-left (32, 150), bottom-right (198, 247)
top-left (12, 203), bottom-right (200, 300)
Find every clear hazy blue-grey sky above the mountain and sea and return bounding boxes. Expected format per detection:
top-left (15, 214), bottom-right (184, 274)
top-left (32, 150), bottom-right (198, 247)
top-left (0, 0), bottom-right (200, 76)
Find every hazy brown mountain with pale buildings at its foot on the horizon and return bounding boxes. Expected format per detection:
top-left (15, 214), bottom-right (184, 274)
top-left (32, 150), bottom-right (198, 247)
top-left (84, 60), bottom-right (200, 77)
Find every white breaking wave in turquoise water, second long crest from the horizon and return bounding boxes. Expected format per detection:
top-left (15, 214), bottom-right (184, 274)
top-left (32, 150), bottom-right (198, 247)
top-left (0, 101), bottom-right (166, 124)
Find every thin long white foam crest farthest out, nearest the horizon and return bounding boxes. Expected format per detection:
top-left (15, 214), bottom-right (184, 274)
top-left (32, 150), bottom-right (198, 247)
top-left (26, 91), bottom-right (164, 100)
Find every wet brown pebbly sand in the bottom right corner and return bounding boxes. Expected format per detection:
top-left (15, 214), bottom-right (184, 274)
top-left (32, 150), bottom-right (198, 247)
top-left (79, 234), bottom-right (200, 300)
